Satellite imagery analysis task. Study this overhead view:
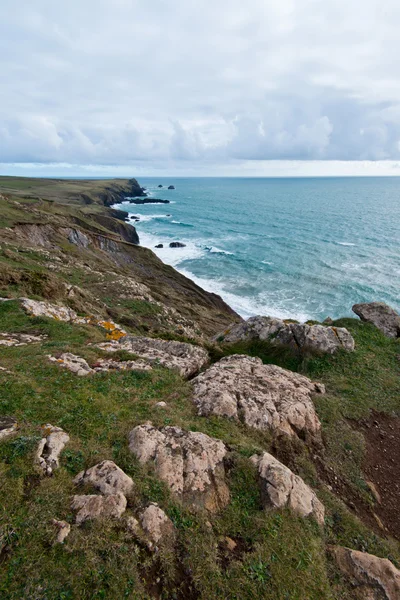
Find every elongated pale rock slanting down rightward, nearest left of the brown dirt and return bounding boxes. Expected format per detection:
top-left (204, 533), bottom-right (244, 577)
top-left (251, 452), bottom-right (325, 525)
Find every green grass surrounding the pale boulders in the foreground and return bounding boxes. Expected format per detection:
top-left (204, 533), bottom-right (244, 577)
top-left (0, 178), bottom-right (400, 600)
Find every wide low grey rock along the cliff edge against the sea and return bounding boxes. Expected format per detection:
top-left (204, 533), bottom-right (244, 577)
top-left (220, 317), bottom-right (354, 354)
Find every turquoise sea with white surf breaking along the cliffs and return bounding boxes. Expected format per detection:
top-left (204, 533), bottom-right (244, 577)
top-left (112, 177), bottom-right (400, 321)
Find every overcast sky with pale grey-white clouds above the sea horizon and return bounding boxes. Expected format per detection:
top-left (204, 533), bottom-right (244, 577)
top-left (0, 0), bottom-right (400, 176)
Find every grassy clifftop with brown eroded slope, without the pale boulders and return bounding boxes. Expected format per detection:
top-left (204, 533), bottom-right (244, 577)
top-left (0, 178), bottom-right (400, 600)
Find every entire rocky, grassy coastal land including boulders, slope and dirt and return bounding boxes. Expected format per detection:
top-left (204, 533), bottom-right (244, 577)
top-left (0, 178), bottom-right (400, 600)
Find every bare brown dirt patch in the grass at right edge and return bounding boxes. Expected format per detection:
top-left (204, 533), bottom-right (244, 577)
top-left (361, 412), bottom-right (400, 539)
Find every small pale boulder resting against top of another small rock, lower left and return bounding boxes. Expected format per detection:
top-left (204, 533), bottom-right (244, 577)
top-left (74, 460), bottom-right (133, 495)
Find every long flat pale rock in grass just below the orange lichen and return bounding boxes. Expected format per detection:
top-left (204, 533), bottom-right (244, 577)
top-left (97, 336), bottom-right (209, 377)
